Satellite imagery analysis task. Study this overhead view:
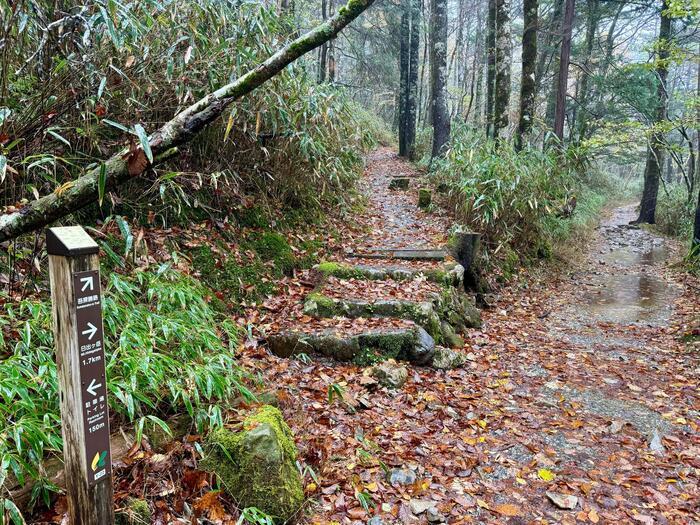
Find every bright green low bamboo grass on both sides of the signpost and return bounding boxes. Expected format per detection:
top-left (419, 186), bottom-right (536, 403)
top-left (0, 266), bottom-right (252, 506)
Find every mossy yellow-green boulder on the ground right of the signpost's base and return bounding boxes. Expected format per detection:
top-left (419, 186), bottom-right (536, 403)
top-left (202, 406), bottom-right (304, 523)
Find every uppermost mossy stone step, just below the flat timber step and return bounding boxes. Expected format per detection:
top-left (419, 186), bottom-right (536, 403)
top-left (314, 262), bottom-right (464, 287)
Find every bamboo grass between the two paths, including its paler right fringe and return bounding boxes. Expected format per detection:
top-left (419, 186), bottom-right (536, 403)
top-left (433, 126), bottom-right (616, 268)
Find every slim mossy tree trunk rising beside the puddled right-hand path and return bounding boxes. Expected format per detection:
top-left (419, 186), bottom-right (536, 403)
top-left (637, 0), bottom-right (671, 224)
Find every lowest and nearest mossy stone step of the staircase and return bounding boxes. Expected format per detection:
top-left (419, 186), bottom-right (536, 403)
top-left (265, 326), bottom-right (467, 370)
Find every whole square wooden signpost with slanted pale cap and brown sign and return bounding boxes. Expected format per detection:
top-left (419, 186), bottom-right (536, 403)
top-left (46, 226), bottom-right (114, 525)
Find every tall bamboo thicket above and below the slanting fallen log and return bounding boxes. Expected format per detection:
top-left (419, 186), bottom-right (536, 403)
top-left (0, 0), bottom-right (384, 222)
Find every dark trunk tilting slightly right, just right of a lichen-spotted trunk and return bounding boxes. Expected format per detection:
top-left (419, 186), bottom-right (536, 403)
top-left (515, 0), bottom-right (539, 150)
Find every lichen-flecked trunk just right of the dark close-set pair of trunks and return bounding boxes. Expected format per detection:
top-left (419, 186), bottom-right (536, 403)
top-left (430, 0), bottom-right (450, 157)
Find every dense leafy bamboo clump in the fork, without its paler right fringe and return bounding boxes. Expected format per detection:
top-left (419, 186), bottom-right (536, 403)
top-left (435, 128), bottom-right (580, 260)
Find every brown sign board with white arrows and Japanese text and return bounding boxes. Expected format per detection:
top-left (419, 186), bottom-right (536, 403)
top-left (73, 270), bottom-right (112, 486)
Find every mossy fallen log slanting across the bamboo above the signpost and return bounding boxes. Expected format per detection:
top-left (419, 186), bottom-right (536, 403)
top-left (0, 0), bottom-right (374, 242)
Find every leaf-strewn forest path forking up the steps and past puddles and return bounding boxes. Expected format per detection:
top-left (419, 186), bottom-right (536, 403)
top-left (244, 149), bottom-right (700, 525)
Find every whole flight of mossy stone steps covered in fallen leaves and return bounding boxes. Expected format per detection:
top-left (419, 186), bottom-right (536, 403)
top-left (267, 250), bottom-right (481, 368)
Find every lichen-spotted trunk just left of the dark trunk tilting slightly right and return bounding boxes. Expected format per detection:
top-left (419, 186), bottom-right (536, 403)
top-left (493, 0), bottom-right (513, 139)
